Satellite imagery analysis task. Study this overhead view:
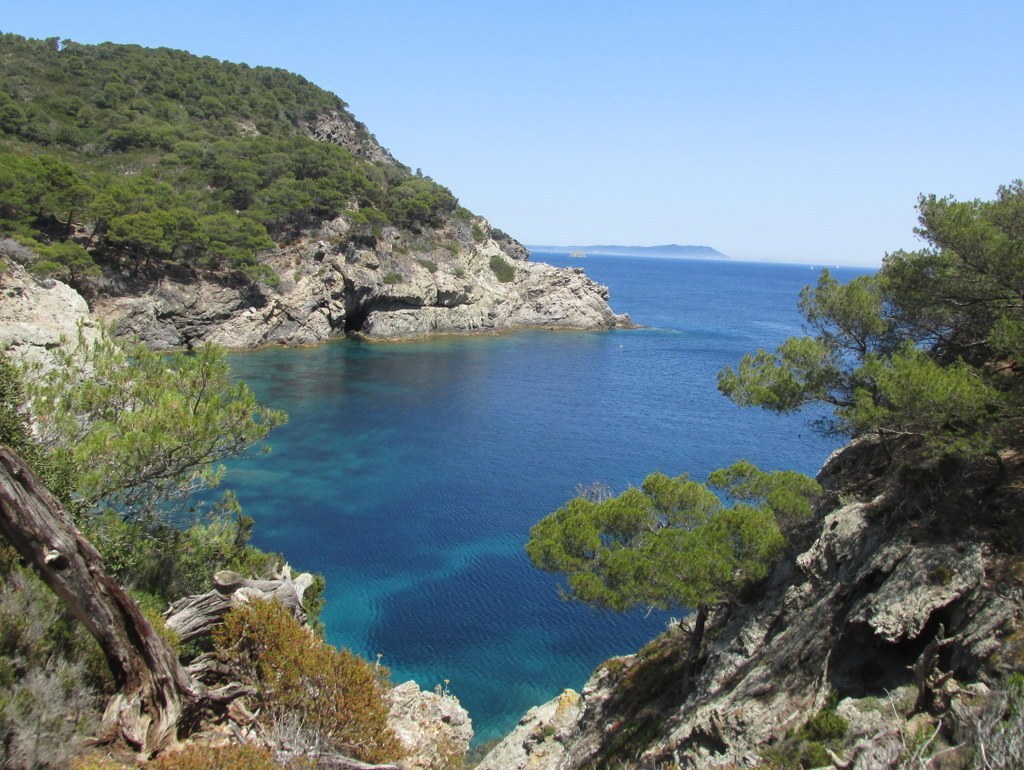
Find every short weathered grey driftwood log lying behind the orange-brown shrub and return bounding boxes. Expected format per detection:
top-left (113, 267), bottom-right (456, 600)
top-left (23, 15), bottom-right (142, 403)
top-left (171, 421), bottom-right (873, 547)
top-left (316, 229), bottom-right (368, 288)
top-left (165, 564), bottom-right (313, 642)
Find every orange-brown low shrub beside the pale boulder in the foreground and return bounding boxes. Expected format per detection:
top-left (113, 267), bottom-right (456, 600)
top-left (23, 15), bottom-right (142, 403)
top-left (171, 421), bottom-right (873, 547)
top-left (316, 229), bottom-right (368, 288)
top-left (214, 600), bottom-right (401, 763)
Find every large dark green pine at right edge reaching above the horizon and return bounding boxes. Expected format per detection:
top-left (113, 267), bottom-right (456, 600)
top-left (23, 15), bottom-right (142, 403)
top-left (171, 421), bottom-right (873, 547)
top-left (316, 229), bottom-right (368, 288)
top-left (719, 180), bottom-right (1024, 459)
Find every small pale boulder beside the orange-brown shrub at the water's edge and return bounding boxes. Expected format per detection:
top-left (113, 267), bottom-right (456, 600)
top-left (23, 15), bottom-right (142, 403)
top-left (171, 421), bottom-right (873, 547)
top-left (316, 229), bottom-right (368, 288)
top-left (388, 682), bottom-right (473, 770)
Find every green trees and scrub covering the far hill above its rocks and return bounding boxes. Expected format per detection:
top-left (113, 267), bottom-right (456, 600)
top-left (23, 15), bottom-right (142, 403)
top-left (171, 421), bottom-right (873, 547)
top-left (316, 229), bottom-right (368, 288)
top-left (0, 34), bottom-right (469, 284)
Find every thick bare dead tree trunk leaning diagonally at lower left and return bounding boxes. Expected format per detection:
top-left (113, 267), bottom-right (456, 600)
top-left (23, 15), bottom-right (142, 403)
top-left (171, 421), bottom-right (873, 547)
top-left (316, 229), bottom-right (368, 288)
top-left (0, 446), bottom-right (204, 755)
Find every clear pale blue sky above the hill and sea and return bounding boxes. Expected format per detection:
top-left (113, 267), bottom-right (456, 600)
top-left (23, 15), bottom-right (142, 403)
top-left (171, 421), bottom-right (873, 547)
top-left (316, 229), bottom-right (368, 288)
top-left (0, 0), bottom-right (1024, 265)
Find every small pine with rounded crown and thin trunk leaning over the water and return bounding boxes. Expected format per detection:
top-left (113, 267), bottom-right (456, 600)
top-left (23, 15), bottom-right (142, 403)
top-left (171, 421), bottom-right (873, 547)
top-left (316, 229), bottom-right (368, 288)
top-left (526, 462), bottom-right (819, 690)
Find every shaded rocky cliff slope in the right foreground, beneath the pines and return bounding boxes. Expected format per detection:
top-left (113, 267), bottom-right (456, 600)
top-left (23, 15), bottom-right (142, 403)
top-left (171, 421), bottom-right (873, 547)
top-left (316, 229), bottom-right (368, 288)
top-left (480, 442), bottom-right (1024, 770)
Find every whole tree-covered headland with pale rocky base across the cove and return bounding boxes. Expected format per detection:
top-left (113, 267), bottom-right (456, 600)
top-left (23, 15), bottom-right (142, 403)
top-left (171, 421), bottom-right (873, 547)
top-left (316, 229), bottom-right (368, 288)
top-left (0, 34), bottom-right (627, 348)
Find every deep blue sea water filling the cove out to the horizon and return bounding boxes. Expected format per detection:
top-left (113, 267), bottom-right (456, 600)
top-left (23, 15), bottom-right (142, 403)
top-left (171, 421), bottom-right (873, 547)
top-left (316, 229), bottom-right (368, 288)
top-left (218, 255), bottom-right (862, 740)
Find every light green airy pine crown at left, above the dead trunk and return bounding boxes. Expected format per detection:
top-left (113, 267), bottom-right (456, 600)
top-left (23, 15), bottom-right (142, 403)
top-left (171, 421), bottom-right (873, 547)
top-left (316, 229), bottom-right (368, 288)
top-left (28, 329), bottom-right (286, 520)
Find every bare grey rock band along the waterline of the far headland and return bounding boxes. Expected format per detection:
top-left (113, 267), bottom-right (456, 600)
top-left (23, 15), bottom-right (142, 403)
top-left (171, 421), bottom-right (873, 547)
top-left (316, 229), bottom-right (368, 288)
top-left (93, 224), bottom-right (630, 349)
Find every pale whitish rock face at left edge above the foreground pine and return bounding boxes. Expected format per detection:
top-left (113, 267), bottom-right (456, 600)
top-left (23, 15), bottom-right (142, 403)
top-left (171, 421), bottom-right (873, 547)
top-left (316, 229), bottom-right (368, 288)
top-left (0, 263), bottom-right (98, 361)
